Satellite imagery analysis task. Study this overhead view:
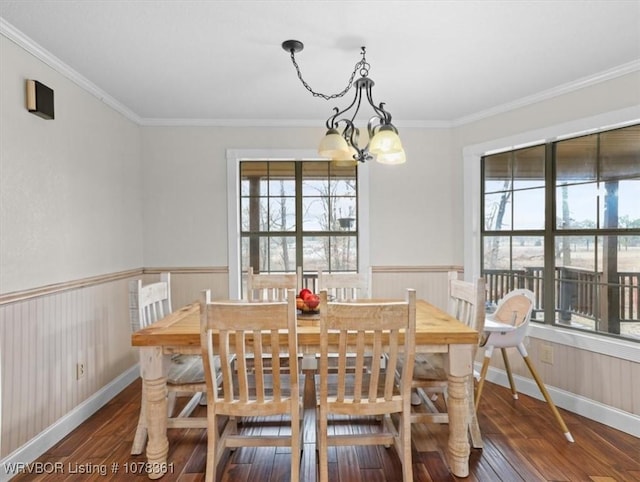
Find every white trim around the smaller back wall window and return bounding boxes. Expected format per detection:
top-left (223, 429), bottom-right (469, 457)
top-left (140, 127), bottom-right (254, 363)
top-left (227, 149), bottom-right (370, 299)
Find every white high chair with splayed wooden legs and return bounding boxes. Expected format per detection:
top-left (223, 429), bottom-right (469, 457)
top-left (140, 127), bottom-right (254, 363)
top-left (475, 289), bottom-right (574, 442)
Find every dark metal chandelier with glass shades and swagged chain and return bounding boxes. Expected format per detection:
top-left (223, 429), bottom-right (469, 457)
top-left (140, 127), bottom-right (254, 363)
top-left (282, 40), bottom-right (407, 165)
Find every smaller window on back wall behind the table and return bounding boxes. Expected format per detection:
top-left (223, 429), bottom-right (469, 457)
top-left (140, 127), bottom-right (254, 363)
top-left (239, 160), bottom-right (359, 290)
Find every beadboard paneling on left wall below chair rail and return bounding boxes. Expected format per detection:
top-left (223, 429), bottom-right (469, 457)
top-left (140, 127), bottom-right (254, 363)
top-left (0, 277), bottom-right (137, 458)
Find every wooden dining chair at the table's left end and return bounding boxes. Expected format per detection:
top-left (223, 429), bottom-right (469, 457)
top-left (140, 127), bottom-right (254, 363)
top-left (129, 273), bottom-right (207, 455)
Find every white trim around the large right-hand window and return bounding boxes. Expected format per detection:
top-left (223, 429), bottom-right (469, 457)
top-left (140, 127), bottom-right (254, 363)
top-left (462, 106), bottom-right (640, 362)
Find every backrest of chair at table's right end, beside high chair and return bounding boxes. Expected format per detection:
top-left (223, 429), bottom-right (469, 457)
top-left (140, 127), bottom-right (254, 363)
top-left (447, 271), bottom-right (486, 333)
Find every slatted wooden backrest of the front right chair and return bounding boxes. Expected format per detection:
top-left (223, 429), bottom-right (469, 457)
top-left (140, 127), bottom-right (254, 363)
top-left (319, 290), bottom-right (416, 415)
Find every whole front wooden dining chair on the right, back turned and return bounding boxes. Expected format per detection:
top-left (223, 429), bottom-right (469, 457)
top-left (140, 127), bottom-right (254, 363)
top-left (316, 290), bottom-right (416, 482)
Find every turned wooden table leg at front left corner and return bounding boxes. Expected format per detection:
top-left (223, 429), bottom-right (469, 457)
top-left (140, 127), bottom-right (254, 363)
top-left (140, 347), bottom-right (169, 479)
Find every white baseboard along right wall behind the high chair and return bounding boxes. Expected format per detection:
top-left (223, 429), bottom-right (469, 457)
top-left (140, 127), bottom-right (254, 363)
top-left (476, 363), bottom-right (640, 437)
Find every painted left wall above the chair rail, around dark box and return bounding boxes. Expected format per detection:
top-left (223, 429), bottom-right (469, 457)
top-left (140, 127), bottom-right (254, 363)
top-left (0, 36), bottom-right (142, 293)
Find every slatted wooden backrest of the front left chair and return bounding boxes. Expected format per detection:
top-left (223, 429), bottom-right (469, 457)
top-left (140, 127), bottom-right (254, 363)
top-left (200, 290), bottom-right (299, 410)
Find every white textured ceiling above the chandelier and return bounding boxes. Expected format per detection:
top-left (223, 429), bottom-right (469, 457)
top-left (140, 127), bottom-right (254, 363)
top-left (0, 0), bottom-right (640, 125)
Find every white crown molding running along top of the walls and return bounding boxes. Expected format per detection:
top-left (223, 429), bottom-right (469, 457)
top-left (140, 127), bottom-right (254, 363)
top-left (5, 17), bottom-right (640, 129)
